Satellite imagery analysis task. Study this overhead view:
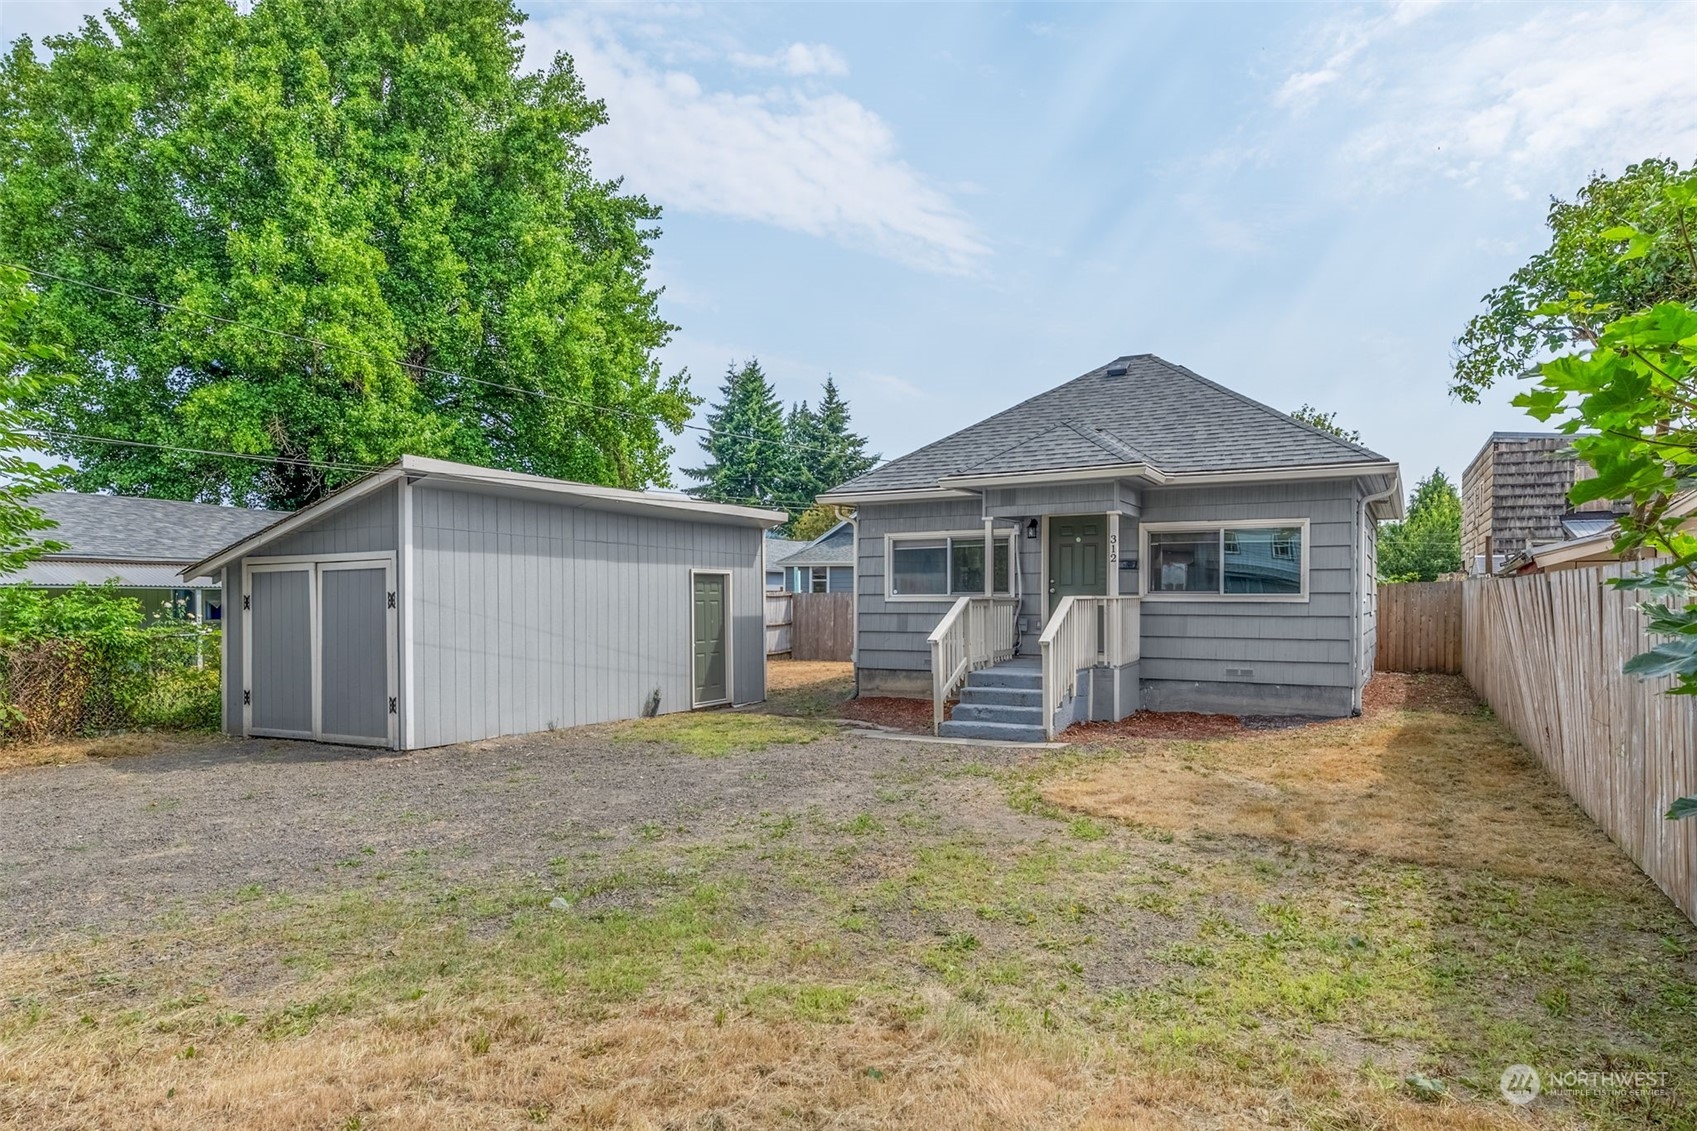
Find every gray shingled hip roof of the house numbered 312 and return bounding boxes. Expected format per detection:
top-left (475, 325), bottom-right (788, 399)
top-left (826, 353), bottom-right (1393, 499)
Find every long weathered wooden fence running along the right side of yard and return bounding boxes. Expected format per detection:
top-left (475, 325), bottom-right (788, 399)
top-left (1461, 562), bottom-right (1697, 920)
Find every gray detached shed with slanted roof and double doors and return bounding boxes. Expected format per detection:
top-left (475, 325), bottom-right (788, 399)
top-left (183, 455), bottom-right (784, 749)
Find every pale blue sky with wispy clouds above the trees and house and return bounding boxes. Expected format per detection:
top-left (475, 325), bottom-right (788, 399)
top-left (0, 0), bottom-right (1697, 486)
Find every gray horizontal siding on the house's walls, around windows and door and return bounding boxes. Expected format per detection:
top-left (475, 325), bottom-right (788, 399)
top-left (855, 479), bottom-right (1376, 715)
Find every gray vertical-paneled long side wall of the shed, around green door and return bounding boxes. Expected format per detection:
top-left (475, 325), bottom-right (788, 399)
top-left (411, 484), bottom-right (765, 746)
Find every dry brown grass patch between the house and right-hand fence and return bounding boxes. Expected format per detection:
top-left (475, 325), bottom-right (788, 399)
top-left (1044, 676), bottom-right (1639, 885)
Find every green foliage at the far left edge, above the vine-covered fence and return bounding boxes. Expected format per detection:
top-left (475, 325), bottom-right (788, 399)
top-left (0, 267), bottom-right (64, 574)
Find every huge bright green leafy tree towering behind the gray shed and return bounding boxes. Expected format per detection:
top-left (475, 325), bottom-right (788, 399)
top-left (0, 0), bottom-right (694, 508)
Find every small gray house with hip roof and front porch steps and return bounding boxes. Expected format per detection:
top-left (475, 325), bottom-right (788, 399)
top-left (823, 355), bottom-right (1402, 740)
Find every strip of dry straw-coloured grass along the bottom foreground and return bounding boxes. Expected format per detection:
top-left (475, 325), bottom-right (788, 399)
top-left (0, 999), bottom-right (1526, 1131)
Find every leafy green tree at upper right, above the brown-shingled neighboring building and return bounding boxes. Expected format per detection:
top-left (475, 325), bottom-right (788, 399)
top-left (1451, 158), bottom-right (1697, 401)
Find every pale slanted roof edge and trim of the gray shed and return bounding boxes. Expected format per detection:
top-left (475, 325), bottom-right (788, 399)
top-left (183, 455), bottom-right (789, 577)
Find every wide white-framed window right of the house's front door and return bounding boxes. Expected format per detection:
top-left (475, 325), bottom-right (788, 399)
top-left (1144, 520), bottom-right (1308, 598)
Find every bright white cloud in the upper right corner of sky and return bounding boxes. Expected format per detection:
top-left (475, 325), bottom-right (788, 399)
top-left (1276, 5), bottom-right (1697, 195)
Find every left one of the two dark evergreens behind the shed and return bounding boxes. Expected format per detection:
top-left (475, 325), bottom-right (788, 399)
top-left (684, 358), bottom-right (787, 515)
